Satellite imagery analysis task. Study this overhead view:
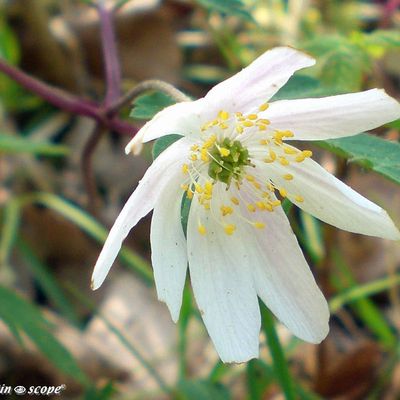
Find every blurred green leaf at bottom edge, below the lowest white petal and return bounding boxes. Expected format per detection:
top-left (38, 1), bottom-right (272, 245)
top-left (176, 380), bottom-right (231, 400)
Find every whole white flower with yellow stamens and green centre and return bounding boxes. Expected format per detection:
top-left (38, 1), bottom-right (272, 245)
top-left (93, 47), bottom-right (400, 362)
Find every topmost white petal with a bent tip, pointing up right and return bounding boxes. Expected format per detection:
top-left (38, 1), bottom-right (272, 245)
top-left (205, 47), bottom-right (315, 112)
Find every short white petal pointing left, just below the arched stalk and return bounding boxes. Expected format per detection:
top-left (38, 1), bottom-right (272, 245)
top-left (125, 99), bottom-right (206, 154)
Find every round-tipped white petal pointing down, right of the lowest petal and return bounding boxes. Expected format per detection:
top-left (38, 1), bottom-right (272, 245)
top-left (233, 190), bottom-right (329, 343)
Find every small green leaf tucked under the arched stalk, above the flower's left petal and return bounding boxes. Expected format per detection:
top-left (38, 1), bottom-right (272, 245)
top-left (130, 92), bottom-right (175, 119)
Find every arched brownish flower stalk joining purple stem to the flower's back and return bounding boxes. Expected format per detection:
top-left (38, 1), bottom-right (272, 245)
top-left (107, 79), bottom-right (191, 115)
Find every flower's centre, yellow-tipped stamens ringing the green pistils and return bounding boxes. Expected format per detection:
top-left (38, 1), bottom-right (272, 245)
top-left (181, 103), bottom-right (312, 235)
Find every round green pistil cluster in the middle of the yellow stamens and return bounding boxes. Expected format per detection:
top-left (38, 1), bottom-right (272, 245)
top-left (208, 138), bottom-right (251, 186)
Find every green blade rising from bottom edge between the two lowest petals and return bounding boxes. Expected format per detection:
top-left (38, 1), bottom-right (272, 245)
top-left (260, 303), bottom-right (296, 400)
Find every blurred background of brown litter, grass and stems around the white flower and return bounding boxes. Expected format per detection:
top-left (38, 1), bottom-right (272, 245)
top-left (0, 0), bottom-right (400, 400)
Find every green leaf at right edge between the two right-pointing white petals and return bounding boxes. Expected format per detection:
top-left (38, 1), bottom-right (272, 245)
top-left (314, 133), bottom-right (400, 184)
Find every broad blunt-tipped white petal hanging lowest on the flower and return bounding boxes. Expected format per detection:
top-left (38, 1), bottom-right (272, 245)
top-left (187, 184), bottom-right (261, 362)
